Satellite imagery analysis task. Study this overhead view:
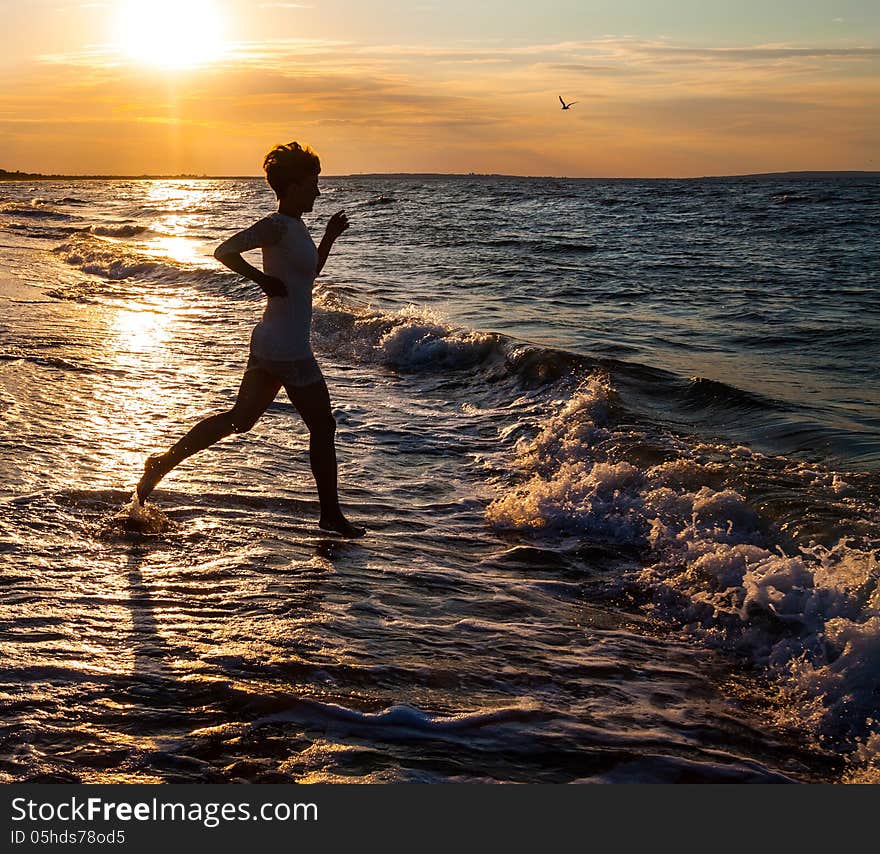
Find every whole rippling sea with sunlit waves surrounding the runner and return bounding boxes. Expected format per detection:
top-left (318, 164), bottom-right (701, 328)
top-left (0, 175), bottom-right (880, 783)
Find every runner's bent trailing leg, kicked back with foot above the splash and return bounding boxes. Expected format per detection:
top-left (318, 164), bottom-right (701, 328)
top-left (137, 370), bottom-right (281, 504)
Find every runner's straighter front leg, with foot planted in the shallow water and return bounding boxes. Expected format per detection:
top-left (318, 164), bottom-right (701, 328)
top-left (285, 379), bottom-right (366, 537)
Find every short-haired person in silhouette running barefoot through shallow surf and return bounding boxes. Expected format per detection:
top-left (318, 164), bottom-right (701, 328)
top-left (137, 142), bottom-right (366, 537)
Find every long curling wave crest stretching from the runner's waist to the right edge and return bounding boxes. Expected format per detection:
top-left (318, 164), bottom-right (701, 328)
top-left (312, 296), bottom-right (878, 467)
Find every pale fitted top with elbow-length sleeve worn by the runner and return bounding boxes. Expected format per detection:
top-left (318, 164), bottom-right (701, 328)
top-left (217, 213), bottom-right (318, 362)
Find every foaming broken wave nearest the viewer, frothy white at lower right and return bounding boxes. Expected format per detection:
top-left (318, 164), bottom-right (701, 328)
top-left (486, 373), bottom-right (880, 780)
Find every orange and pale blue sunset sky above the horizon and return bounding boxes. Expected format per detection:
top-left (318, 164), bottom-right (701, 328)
top-left (0, 0), bottom-right (880, 177)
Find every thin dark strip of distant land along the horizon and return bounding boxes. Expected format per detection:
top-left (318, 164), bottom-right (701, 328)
top-left (0, 169), bottom-right (880, 181)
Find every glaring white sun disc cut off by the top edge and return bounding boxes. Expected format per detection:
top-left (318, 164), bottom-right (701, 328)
top-left (119, 0), bottom-right (223, 68)
